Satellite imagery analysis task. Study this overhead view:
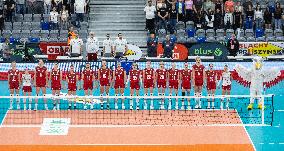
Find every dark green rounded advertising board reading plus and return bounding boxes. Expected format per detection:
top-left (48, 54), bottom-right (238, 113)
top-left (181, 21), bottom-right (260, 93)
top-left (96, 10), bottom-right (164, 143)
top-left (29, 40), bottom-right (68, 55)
top-left (189, 43), bottom-right (228, 60)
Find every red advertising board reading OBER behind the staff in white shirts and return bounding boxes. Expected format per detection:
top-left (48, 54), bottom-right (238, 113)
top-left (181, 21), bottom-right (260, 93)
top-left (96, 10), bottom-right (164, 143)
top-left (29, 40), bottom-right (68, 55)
top-left (39, 42), bottom-right (69, 60)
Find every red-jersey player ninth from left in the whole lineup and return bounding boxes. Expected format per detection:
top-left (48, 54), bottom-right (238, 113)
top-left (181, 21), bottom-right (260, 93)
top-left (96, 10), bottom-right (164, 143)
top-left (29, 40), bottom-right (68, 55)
top-left (128, 63), bottom-right (142, 110)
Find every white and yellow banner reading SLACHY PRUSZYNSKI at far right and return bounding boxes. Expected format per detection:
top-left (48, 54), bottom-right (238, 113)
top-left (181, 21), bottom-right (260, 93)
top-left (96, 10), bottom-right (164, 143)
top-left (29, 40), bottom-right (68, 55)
top-left (238, 42), bottom-right (284, 57)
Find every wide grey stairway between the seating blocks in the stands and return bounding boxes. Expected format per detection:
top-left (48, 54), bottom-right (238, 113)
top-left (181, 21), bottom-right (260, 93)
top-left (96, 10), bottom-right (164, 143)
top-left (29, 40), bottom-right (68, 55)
top-left (89, 0), bottom-right (147, 47)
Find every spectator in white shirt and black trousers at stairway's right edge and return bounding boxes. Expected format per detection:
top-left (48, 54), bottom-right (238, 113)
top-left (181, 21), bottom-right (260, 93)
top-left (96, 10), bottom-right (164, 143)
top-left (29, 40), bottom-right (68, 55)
top-left (144, 1), bottom-right (156, 31)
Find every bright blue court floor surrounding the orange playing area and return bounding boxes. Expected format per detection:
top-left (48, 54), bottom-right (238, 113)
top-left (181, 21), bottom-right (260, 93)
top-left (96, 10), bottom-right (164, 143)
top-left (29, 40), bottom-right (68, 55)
top-left (0, 81), bottom-right (284, 151)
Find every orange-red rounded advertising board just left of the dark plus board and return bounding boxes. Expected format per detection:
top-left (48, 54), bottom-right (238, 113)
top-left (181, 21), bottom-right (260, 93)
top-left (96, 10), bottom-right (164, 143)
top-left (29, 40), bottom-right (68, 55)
top-left (157, 44), bottom-right (188, 60)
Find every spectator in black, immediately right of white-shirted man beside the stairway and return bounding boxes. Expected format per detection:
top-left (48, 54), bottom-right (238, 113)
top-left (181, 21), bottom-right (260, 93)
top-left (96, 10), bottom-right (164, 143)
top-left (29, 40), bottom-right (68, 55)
top-left (157, 1), bottom-right (169, 29)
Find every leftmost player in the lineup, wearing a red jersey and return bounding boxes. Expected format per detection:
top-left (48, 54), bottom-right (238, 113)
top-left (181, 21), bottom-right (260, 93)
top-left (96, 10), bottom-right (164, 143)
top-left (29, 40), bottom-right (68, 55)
top-left (8, 61), bottom-right (21, 110)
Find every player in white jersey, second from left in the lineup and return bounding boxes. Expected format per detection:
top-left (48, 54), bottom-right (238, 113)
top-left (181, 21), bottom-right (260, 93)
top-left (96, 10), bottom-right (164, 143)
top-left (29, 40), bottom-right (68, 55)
top-left (22, 68), bottom-right (32, 110)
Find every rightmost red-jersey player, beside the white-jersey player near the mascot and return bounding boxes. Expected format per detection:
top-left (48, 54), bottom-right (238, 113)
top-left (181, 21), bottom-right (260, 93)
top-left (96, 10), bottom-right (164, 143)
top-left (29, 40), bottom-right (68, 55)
top-left (205, 63), bottom-right (218, 109)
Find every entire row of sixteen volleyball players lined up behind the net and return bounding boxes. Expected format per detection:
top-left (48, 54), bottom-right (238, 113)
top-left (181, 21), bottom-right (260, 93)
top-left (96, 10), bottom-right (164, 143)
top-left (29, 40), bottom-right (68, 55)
top-left (8, 57), bottom-right (231, 110)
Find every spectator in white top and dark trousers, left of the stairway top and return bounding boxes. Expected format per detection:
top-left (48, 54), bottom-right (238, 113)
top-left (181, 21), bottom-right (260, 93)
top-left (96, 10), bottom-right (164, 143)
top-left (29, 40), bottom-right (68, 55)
top-left (74, 0), bottom-right (86, 28)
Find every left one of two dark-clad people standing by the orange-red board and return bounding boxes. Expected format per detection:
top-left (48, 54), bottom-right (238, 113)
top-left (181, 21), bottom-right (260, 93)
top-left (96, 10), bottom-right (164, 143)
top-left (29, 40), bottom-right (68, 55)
top-left (147, 32), bottom-right (158, 57)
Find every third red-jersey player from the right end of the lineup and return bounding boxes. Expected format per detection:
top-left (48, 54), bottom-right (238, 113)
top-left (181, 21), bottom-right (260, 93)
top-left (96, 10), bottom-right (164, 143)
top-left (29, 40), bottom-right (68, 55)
top-left (180, 63), bottom-right (192, 108)
